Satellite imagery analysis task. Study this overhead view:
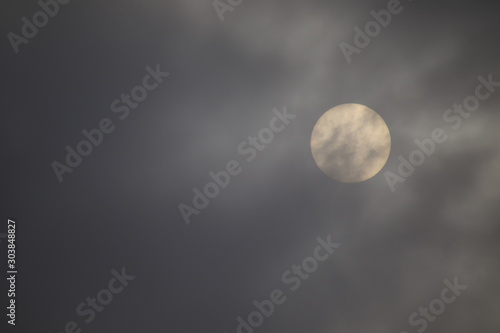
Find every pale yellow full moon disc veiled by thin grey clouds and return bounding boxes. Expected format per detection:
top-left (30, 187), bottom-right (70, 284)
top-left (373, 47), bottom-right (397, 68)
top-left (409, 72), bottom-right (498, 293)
top-left (311, 104), bottom-right (391, 183)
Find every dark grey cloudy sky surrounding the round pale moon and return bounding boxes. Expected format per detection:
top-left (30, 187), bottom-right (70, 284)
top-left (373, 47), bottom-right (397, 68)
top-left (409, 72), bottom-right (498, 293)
top-left (0, 0), bottom-right (500, 333)
